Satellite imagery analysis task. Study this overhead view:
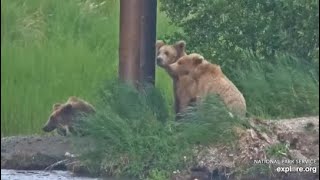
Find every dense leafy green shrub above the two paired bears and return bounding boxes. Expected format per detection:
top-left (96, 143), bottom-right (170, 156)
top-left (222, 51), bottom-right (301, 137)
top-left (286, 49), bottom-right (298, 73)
top-left (161, 0), bottom-right (319, 65)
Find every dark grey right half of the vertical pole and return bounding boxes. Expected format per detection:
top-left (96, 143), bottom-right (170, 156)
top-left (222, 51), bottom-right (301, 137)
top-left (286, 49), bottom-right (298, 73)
top-left (140, 0), bottom-right (157, 85)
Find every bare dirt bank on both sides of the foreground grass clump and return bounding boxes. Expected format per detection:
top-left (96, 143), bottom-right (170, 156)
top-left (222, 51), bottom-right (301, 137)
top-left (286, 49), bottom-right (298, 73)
top-left (1, 116), bottom-right (319, 180)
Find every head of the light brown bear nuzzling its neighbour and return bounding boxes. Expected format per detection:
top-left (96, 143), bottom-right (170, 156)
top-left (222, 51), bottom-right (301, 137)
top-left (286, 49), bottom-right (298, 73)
top-left (168, 53), bottom-right (206, 76)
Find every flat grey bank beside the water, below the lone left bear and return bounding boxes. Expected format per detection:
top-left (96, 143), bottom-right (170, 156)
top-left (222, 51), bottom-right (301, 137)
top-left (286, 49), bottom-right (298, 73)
top-left (1, 135), bottom-right (71, 170)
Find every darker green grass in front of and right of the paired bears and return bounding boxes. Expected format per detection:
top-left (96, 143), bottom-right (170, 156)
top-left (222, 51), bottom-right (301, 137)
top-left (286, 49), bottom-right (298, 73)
top-left (74, 55), bottom-right (319, 179)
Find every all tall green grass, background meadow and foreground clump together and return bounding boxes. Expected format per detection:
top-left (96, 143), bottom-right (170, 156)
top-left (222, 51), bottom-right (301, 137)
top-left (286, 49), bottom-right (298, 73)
top-left (1, 0), bottom-right (319, 178)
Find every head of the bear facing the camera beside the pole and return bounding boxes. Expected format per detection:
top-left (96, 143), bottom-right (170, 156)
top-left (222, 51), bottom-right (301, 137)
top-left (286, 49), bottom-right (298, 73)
top-left (156, 40), bottom-right (186, 69)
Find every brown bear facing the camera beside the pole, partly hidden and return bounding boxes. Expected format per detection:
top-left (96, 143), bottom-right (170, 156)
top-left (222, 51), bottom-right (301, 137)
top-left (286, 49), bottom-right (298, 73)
top-left (156, 40), bottom-right (196, 114)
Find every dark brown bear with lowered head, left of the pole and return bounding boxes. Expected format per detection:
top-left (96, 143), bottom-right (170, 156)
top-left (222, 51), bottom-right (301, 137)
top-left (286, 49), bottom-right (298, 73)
top-left (42, 96), bottom-right (95, 136)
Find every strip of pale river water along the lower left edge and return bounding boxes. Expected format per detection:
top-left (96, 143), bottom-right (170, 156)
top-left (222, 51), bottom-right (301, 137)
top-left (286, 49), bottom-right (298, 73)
top-left (1, 169), bottom-right (101, 180)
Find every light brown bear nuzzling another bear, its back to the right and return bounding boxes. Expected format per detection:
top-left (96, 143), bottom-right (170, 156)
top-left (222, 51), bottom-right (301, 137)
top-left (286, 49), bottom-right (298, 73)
top-left (168, 53), bottom-right (246, 116)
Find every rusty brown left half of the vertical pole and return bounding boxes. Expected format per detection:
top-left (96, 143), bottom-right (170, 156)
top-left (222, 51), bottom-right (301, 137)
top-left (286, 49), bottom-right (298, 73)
top-left (119, 0), bottom-right (142, 85)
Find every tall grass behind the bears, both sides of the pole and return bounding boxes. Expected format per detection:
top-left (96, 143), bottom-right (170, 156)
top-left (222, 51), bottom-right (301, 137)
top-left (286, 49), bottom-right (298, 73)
top-left (1, 0), bottom-right (319, 136)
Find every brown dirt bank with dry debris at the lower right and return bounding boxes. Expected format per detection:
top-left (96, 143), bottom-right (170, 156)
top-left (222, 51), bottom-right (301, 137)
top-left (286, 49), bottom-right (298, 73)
top-left (172, 116), bottom-right (319, 180)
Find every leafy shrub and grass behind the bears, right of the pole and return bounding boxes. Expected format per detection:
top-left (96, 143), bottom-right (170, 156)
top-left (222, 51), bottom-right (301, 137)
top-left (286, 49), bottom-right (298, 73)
top-left (160, 0), bottom-right (319, 118)
